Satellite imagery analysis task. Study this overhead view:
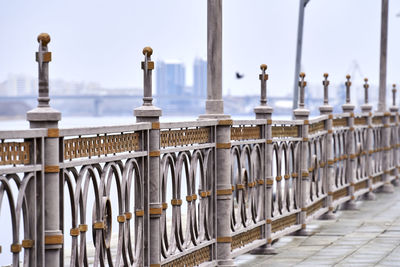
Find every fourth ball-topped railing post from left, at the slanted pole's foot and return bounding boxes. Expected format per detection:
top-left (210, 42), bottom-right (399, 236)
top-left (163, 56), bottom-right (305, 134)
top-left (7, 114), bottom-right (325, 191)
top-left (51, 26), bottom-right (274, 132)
top-left (293, 72), bottom-right (310, 235)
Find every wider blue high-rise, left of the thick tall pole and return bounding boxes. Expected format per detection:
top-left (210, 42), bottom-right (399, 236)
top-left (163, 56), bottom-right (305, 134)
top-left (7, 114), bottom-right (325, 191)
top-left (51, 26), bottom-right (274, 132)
top-left (156, 61), bottom-right (185, 96)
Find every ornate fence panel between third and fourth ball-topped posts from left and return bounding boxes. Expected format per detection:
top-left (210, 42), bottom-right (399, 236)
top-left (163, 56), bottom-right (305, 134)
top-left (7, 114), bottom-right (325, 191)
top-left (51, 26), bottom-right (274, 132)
top-left (269, 121), bottom-right (303, 239)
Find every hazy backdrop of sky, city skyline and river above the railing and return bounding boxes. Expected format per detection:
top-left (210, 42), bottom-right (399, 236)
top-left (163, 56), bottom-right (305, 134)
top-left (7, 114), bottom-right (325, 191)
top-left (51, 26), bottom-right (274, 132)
top-left (0, 0), bottom-right (400, 122)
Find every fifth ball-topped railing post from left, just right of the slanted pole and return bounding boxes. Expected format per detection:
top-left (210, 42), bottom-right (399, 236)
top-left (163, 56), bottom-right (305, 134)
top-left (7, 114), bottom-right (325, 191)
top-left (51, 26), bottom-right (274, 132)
top-left (319, 73), bottom-right (336, 220)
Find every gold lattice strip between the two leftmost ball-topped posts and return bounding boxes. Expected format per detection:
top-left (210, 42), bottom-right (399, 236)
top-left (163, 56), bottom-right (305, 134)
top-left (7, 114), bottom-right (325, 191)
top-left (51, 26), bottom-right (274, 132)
top-left (64, 133), bottom-right (139, 160)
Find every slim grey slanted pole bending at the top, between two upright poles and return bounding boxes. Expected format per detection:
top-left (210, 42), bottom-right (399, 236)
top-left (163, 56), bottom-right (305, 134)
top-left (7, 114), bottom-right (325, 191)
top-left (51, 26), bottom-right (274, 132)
top-left (293, 0), bottom-right (310, 110)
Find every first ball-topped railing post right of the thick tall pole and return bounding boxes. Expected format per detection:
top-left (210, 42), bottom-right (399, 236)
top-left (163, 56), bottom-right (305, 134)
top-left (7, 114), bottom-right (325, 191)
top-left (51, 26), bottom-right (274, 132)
top-left (251, 64), bottom-right (275, 254)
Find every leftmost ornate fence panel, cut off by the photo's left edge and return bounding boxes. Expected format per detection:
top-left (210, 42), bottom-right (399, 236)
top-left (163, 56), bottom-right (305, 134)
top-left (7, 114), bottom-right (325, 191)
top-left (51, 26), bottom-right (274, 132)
top-left (0, 129), bottom-right (47, 266)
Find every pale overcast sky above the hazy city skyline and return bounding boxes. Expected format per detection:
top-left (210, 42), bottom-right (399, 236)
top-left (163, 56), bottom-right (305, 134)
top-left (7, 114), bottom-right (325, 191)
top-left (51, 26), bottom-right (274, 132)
top-left (0, 0), bottom-right (400, 95)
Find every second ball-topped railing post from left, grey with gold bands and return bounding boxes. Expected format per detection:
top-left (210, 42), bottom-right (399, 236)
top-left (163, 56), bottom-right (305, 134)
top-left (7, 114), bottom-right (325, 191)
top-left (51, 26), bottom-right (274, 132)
top-left (134, 47), bottom-right (162, 266)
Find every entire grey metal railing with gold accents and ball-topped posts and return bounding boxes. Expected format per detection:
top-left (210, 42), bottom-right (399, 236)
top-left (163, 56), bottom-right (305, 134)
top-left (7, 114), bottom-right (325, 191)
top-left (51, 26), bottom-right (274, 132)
top-left (0, 36), bottom-right (400, 266)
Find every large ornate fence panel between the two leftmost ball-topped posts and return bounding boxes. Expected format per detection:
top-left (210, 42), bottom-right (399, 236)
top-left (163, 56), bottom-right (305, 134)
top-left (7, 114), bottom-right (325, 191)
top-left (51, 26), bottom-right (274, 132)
top-left (60, 123), bottom-right (151, 266)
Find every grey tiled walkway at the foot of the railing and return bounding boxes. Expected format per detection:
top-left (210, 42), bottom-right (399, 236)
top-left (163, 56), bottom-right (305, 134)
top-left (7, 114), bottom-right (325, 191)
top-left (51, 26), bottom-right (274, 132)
top-left (235, 187), bottom-right (400, 267)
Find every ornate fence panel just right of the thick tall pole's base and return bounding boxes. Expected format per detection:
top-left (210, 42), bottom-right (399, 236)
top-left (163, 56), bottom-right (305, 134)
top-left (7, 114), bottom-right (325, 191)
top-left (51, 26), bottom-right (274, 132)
top-left (231, 120), bottom-right (265, 255)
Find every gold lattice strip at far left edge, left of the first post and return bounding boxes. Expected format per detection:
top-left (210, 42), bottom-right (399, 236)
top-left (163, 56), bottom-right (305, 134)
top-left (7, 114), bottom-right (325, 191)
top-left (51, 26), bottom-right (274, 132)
top-left (0, 142), bottom-right (30, 165)
